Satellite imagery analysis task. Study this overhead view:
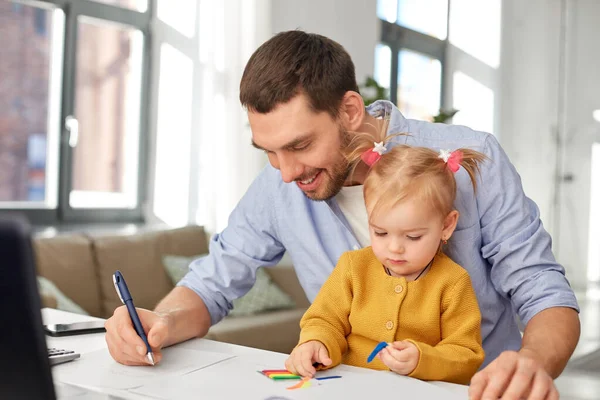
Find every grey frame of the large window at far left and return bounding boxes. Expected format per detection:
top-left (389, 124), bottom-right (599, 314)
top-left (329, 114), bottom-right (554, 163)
top-left (0, 0), bottom-right (152, 226)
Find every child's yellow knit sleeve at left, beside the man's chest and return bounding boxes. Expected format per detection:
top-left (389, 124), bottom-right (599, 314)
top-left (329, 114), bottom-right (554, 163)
top-left (298, 253), bottom-right (352, 368)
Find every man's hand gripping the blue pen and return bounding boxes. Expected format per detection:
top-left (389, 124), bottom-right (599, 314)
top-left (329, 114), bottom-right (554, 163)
top-left (104, 306), bottom-right (169, 365)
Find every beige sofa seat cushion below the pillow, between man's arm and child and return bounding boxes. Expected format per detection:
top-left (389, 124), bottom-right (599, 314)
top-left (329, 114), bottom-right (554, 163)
top-left (206, 309), bottom-right (306, 354)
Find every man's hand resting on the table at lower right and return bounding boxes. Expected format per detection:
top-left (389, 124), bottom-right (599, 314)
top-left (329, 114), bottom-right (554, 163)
top-left (469, 349), bottom-right (559, 400)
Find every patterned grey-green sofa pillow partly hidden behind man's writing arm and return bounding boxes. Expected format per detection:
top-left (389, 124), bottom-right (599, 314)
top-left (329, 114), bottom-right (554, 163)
top-left (163, 254), bottom-right (296, 316)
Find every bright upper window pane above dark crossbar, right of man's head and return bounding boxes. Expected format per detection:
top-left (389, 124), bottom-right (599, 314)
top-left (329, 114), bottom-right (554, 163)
top-left (397, 0), bottom-right (446, 40)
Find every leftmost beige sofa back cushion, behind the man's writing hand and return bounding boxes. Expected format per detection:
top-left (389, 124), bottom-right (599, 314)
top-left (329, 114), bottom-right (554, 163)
top-left (34, 235), bottom-right (102, 316)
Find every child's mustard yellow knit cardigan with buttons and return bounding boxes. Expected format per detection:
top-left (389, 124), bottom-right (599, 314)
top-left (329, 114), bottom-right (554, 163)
top-left (299, 247), bottom-right (484, 384)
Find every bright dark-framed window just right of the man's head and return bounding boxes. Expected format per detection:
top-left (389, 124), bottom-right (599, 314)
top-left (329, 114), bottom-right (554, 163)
top-left (375, 0), bottom-right (448, 119)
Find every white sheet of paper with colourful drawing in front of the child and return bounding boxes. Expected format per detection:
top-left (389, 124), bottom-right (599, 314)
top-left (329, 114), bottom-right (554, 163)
top-left (131, 356), bottom-right (462, 400)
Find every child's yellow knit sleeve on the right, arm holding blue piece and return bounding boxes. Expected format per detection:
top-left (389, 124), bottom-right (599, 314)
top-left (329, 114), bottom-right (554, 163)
top-left (408, 272), bottom-right (484, 384)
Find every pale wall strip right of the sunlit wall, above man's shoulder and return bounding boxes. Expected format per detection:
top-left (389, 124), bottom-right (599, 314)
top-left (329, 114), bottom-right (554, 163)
top-left (500, 0), bottom-right (560, 230)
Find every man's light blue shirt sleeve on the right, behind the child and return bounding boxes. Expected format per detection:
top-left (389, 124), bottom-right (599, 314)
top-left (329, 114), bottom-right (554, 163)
top-left (477, 135), bottom-right (579, 324)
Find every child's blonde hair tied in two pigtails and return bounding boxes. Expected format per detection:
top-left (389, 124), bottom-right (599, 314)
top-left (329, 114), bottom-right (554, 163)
top-left (346, 131), bottom-right (487, 219)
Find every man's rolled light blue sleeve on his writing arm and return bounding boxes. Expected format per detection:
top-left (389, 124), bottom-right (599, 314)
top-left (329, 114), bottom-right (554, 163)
top-left (178, 167), bottom-right (285, 325)
